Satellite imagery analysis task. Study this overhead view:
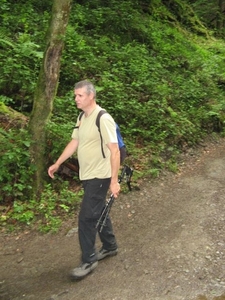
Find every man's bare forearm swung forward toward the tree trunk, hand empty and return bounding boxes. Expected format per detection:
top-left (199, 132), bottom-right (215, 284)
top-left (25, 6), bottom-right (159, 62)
top-left (48, 139), bottom-right (78, 178)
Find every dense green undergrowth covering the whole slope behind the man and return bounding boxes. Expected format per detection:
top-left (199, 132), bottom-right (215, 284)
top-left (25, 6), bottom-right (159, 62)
top-left (0, 0), bottom-right (225, 231)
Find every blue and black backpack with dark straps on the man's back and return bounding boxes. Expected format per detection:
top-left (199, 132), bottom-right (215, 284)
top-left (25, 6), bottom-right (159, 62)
top-left (79, 109), bottom-right (127, 164)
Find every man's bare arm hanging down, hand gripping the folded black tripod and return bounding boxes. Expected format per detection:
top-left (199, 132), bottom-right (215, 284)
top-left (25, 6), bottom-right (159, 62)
top-left (107, 143), bottom-right (120, 198)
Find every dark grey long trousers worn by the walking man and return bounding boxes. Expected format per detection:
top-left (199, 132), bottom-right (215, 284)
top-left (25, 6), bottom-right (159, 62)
top-left (78, 178), bottom-right (117, 263)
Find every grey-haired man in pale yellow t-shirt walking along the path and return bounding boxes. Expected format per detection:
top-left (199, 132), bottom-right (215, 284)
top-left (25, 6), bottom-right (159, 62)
top-left (48, 80), bottom-right (120, 279)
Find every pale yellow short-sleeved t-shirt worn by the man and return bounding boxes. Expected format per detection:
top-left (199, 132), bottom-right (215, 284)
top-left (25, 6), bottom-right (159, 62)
top-left (72, 106), bottom-right (118, 180)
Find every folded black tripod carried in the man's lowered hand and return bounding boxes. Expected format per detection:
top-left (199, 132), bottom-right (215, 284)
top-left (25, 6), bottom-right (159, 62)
top-left (95, 166), bottom-right (133, 232)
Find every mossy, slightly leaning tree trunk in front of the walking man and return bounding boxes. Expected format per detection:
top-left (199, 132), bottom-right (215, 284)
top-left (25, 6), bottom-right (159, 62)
top-left (29, 0), bottom-right (72, 196)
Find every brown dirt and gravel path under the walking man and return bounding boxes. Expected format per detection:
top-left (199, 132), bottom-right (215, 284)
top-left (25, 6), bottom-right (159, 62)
top-left (0, 139), bottom-right (225, 300)
